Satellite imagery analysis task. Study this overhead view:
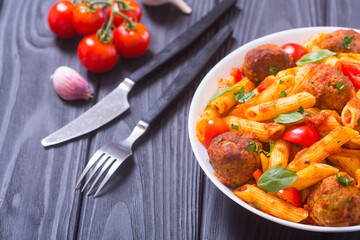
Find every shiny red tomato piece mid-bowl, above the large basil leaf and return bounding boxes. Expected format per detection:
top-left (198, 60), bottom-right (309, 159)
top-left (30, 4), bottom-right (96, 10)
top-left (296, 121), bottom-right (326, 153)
top-left (282, 124), bottom-right (320, 147)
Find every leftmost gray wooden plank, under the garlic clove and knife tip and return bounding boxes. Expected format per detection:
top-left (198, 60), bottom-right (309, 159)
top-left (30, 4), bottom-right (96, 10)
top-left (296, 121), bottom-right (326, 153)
top-left (0, 0), bottom-right (96, 239)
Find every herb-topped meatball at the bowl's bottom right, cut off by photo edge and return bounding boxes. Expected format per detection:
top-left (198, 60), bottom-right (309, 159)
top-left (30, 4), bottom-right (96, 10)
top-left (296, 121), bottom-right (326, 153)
top-left (306, 172), bottom-right (360, 226)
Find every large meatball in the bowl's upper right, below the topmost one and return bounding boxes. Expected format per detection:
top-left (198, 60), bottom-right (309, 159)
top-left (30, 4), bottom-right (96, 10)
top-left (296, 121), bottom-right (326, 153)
top-left (302, 64), bottom-right (355, 113)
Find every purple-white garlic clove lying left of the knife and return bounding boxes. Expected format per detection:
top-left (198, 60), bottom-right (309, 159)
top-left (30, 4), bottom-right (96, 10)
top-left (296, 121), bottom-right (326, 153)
top-left (50, 66), bottom-right (93, 100)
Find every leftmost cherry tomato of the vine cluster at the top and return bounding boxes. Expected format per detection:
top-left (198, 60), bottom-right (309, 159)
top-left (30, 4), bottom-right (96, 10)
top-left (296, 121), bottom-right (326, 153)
top-left (47, 1), bottom-right (77, 38)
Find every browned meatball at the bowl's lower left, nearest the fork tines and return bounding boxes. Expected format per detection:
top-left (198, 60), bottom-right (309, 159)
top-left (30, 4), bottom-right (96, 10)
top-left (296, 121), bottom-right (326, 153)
top-left (208, 132), bottom-right (262, 188)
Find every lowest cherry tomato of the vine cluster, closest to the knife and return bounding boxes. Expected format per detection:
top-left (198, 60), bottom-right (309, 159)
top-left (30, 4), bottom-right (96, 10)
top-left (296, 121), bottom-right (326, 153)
top-left (78, 34), bottom-right (118, 73)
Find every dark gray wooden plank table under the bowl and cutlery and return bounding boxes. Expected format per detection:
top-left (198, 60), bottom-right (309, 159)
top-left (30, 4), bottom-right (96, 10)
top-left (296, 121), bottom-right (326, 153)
top-left (0, 0), bottom-right (360, 240)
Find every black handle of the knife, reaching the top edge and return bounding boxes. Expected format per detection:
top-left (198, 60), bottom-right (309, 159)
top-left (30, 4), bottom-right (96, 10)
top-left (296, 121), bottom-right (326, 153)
top-left (129, 0), bottom-right (236, 82)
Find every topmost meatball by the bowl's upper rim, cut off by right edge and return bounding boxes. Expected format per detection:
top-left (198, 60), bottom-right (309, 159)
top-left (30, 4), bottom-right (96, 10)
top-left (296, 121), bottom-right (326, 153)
top-left (320, 30), bottom-right (360, 53)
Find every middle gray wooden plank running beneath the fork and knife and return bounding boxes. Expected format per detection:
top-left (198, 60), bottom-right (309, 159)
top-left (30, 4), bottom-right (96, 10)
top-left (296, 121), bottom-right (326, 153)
top-left (78, 0), bottom-right (231, 239)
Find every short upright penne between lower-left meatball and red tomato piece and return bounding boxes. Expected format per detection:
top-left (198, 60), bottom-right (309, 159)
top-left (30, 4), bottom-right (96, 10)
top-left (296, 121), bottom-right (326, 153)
top-left (269, 139), bottom-right (291, 168)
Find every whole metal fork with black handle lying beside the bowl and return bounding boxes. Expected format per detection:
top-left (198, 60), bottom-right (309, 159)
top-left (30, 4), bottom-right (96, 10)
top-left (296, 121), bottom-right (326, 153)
top-left (76, 26), bottom-right (232, 197)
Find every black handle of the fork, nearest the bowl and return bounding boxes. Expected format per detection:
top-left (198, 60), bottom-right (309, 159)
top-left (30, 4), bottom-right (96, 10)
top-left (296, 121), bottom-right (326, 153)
top-left (142, 26), bottom-right (232, 125)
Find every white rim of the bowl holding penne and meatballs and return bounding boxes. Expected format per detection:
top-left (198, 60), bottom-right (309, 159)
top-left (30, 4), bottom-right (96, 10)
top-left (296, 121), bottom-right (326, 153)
top-left (188, 26), bottom-right (360, 232)
